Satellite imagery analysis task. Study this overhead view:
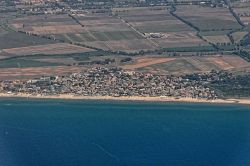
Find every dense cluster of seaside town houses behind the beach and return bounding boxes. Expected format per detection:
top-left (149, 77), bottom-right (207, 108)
top-left (0, 67), bottom-right (217, 99)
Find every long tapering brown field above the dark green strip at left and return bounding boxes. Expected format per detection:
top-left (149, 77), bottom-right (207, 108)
top-left (3, 43), bottom-right (92, 56)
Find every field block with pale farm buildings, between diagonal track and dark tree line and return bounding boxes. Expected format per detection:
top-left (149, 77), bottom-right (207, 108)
top-left (113, 7), bottom-right (209, 48)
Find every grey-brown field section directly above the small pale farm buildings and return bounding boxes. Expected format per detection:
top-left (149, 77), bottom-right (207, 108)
top-left (116, 7), bottom-right (193, 33)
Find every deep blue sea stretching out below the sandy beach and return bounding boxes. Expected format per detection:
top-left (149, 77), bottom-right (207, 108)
top-left (0, 98), bottom-right (250, 166)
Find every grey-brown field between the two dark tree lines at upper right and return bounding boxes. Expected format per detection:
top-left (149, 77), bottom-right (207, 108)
top-left (175, 5), bottom-right (241, 31)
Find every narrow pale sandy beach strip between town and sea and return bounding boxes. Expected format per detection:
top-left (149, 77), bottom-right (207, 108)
top-left (0, 93), bottom-right (250, 105)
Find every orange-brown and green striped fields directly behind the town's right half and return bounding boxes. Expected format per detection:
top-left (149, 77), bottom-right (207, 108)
top-left (123, 55), bottom-right (250, 74)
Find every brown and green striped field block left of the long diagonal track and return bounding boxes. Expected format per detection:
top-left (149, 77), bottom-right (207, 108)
top-left (12, 14), bottom-right (156, 52)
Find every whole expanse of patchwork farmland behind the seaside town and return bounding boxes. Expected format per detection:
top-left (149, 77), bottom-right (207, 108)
top-left (0, 0), bottom-right (250, 78)
